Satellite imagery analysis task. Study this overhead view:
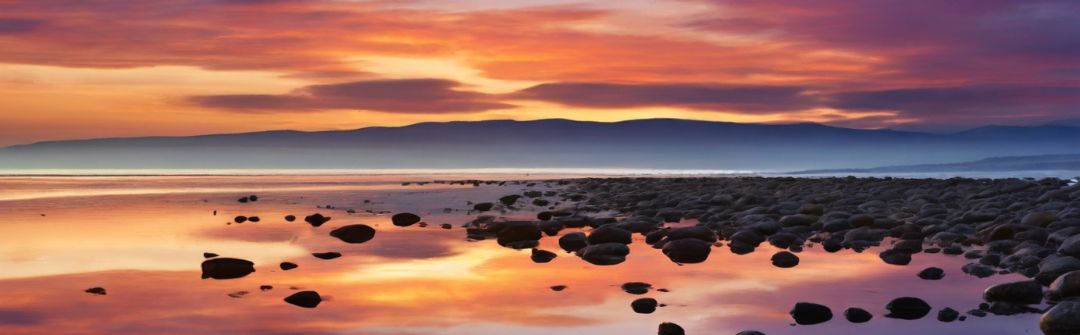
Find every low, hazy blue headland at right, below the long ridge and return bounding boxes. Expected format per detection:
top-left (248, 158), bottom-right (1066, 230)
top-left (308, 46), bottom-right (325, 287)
top-left (793, 155), bottom-right (1080, 174)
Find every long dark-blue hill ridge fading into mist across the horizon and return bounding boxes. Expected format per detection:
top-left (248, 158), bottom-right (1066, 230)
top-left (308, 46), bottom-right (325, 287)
top-left (0, 119), bottom-right (1080, 171)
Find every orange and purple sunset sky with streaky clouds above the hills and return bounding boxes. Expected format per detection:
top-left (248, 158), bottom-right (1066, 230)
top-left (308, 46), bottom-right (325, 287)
top-left (0, 0), bottom-right (1080, 146)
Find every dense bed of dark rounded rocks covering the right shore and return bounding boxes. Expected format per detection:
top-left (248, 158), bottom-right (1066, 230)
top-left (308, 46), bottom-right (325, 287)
top-left (457, 177), bottom-right (1080, 334)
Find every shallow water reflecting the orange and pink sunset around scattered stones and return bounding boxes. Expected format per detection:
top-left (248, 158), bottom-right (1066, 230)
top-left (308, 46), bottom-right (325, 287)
top-left (0, 175), bottom-right (1040, 335)
